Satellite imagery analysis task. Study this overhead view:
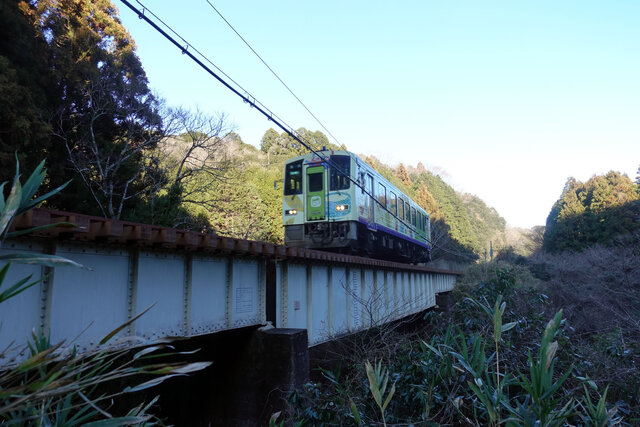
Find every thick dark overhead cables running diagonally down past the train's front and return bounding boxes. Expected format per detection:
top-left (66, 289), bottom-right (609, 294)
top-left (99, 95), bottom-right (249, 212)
top-left (120, 0), bottom-right (431, 244)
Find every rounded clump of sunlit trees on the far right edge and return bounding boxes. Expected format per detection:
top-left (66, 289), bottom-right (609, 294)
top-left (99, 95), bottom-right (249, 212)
top-left (544, 169), bottom-right (640, 252)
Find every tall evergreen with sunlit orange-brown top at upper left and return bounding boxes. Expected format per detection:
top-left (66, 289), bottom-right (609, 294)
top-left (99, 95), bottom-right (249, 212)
top-left (20, 0), bottom-right (163, 218)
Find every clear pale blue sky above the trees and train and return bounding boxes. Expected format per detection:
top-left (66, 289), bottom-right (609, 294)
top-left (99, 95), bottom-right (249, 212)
top-left (114, 0), bottom-right (640, 227)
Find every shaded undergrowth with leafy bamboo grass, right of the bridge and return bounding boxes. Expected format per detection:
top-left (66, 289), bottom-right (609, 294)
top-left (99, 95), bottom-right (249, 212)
top-left (282, 246), bottom-right (640, 426)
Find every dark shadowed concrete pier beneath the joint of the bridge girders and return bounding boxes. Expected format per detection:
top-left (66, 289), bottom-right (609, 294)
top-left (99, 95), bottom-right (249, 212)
top-left (150, 327), bottom-right (309, 427)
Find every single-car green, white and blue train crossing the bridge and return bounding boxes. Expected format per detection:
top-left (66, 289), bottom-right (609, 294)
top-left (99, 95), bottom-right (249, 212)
top-left (282, 147), bottom-right (431, 263)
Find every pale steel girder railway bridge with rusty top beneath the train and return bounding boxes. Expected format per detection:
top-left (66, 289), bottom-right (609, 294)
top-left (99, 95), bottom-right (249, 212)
top-left (0, 209), bottom-right (458, 424)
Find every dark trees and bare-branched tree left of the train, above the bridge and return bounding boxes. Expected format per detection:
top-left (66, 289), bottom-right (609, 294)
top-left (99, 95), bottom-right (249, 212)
top-left (0, 0), bottom-right (235, 225)
